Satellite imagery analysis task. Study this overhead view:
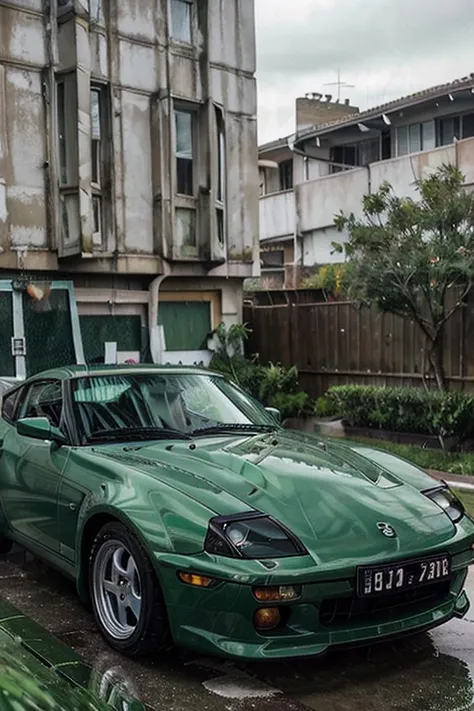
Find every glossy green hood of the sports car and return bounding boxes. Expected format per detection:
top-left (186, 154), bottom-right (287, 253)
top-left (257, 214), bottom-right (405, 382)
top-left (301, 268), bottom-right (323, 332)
top-left (96, 431), bottom-right (456, 564)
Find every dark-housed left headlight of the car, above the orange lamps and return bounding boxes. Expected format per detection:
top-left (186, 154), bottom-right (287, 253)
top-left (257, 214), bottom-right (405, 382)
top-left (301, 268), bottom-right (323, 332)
top-left (204, 511), bottom-right (307, 559)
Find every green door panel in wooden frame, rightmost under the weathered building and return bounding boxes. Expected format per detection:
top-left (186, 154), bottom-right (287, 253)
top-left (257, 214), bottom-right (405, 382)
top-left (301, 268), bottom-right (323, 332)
top-left (158, 301), bottom-right (211, 351)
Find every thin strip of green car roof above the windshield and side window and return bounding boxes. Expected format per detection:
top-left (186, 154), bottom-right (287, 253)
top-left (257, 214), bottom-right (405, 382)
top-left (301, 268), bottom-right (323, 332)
top-left (27, 363), bottom-right (219, 382)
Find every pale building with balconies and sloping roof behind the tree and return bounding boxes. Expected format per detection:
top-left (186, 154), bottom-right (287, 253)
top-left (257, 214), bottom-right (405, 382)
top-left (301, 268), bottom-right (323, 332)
top-left (259, 74), bottom-right (474, 288)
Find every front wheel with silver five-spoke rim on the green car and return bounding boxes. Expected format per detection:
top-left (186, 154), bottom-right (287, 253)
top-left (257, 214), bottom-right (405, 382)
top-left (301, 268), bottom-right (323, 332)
top-left (89, 522), bottom-right (170, 657)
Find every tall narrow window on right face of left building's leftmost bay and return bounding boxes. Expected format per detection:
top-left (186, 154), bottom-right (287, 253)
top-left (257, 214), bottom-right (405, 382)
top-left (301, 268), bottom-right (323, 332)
top-left (91, 87), bottom-right (104, 246)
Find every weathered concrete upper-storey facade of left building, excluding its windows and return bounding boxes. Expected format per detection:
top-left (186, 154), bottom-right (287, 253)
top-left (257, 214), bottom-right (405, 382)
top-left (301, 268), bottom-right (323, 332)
top-left (0, 0), bottom-right (258, 278)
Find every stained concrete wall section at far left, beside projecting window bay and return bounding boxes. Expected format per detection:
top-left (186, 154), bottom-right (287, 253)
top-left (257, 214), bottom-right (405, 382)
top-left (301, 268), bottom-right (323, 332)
top-left (0, 0), bottom-right (48, 258)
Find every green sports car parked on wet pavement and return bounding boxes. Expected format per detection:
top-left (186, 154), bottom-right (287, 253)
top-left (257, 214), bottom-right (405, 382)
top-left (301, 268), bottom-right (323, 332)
top-left (0, 366), bottom-right (474, 660)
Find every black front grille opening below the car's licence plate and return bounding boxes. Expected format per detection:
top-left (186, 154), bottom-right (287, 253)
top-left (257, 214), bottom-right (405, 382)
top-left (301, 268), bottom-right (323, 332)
top-left (319, 582), bottom-right (450, 627)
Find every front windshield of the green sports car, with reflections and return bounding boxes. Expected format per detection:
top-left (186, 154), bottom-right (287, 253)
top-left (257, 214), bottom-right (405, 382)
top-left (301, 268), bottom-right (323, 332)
top-left (72, 373), bottom-right (276, 442)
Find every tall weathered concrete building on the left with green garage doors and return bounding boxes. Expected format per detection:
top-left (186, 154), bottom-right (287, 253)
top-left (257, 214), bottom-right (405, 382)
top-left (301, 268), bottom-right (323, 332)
top-left (0, 0), bottom-right (259, 377)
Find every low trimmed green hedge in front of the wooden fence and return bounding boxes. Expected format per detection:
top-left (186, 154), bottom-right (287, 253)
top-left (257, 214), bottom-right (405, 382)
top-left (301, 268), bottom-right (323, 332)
top-left (316, 385), bottom-right (474, 440)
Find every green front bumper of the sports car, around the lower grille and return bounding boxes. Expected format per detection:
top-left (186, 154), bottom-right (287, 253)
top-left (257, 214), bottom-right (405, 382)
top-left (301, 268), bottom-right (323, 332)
top-left (160, 548), bottom-right (474, 661)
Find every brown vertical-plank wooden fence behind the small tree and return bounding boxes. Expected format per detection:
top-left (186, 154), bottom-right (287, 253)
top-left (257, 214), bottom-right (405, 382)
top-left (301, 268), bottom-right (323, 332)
top-left (244, 298), bottom-right (474, 397)
